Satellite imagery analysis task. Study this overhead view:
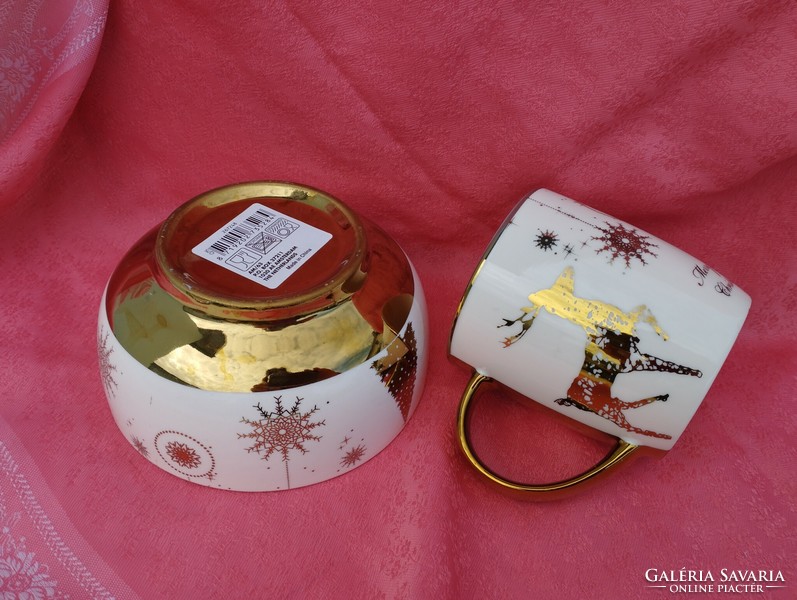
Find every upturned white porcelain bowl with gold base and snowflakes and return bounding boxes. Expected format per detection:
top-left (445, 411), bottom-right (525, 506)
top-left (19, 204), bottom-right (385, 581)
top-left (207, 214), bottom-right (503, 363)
top-left (97, 182), bottom-right (427, 491)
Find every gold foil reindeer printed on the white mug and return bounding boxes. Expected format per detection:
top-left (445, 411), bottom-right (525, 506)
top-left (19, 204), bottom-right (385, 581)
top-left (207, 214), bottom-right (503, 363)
top-left (499, 267), bottom-right (702, 439)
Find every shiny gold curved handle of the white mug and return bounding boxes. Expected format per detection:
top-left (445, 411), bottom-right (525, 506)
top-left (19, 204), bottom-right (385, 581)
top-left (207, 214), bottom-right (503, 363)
top-left (457, 372), bottom-right (639, 500)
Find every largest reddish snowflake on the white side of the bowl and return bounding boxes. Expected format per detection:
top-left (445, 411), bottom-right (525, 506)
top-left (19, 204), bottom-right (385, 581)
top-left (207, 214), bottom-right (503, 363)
top-left (238, 396), bottom-right (325, 462)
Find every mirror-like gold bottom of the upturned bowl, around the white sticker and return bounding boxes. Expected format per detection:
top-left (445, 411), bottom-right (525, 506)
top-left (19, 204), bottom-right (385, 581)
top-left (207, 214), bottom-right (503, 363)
top-left (106, 182), bottom-right (415, 392)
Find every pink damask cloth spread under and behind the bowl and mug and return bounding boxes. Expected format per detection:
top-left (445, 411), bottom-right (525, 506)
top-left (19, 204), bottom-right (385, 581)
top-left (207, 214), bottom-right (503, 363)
top-left (0, 0), bottom-right (797, 600)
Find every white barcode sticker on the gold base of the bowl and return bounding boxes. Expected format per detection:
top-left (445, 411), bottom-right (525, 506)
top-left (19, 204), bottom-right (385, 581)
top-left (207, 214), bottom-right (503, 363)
top-left (192, 204), bottom-right (332, 289)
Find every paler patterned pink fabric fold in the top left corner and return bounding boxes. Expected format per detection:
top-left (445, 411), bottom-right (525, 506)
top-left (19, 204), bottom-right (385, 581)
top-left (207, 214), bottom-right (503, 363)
top-left (0, 0), bottom-right (108, 202)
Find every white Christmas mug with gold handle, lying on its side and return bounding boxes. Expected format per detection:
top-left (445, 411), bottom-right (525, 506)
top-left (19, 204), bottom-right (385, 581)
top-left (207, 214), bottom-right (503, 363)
top-left (449, 190), bottom-right (750, 495)
